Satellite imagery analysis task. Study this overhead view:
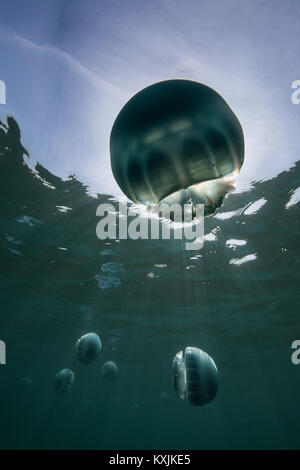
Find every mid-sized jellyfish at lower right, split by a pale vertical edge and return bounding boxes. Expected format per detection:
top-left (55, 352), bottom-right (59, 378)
top-left (173, 347), bottom-right (219, 406)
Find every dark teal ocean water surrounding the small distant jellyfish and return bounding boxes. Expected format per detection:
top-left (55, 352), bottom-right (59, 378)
top-left (0, 115), bottom-right (300, 449)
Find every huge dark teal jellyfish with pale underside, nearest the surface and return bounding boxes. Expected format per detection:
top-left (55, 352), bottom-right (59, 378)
top-left (110, 80), bottom-right (244, 215)
